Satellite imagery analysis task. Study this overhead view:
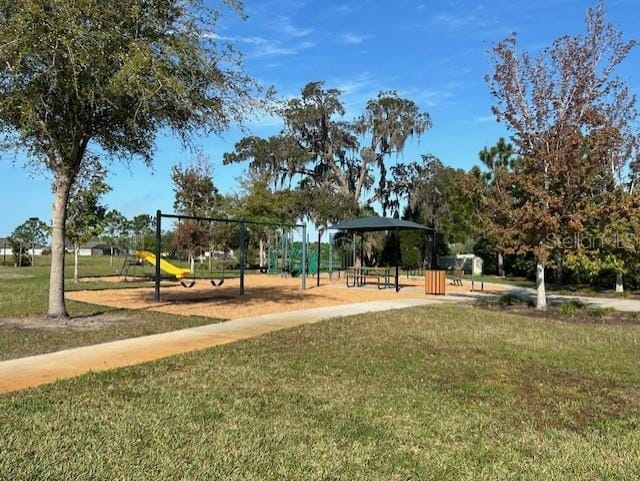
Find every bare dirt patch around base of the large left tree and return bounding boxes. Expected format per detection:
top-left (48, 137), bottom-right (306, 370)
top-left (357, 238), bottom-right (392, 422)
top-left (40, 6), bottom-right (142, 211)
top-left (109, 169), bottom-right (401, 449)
top-left (0, 314), bottom-right (139, 331)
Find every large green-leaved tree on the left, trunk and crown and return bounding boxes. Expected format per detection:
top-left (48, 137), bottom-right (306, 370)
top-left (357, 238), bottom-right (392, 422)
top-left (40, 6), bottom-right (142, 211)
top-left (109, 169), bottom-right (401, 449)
top-left (0, 0), bottom-right (254, 318)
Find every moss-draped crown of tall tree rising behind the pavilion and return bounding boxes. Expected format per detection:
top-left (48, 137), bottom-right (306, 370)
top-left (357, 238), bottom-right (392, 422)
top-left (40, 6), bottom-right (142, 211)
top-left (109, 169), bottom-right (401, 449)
top-left (224, 82), bottom-right (431, 213)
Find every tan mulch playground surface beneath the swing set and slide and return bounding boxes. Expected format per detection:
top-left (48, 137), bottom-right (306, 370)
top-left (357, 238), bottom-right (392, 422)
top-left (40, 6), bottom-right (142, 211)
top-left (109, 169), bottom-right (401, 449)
top-left (67, 274), bottom-right (506, 319)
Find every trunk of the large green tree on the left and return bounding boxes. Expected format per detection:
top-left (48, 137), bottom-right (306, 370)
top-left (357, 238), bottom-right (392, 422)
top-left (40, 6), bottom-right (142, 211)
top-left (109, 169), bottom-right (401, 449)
top-left (47, 178), bottom-right (71, 318)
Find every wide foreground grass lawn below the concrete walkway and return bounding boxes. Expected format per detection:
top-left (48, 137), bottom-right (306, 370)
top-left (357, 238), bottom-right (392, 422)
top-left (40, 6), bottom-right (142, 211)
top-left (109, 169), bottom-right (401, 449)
top-left (0, 306), bottom-right (640, 481)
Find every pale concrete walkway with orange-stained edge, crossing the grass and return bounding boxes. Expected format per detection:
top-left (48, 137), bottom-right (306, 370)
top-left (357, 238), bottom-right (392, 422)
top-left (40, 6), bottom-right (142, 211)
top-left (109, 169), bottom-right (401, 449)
top-left (0, 296), bottom-right (456, 393)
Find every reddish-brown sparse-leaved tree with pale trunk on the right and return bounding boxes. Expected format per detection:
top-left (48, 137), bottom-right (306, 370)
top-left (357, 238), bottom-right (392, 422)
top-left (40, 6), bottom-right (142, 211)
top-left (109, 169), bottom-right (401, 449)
top-left (487, 3), bottom-right (636, 309)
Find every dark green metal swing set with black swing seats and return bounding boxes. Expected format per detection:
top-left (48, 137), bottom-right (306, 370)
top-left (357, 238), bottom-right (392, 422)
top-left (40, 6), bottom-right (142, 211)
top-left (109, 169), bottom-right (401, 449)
top-left (154, 210), bottom-right (308, 302)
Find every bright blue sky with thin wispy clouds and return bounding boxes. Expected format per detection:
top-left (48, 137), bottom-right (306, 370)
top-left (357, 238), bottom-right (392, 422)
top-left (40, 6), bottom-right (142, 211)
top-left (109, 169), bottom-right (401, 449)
top-left (0, 0), bottom-right (640, 236)
